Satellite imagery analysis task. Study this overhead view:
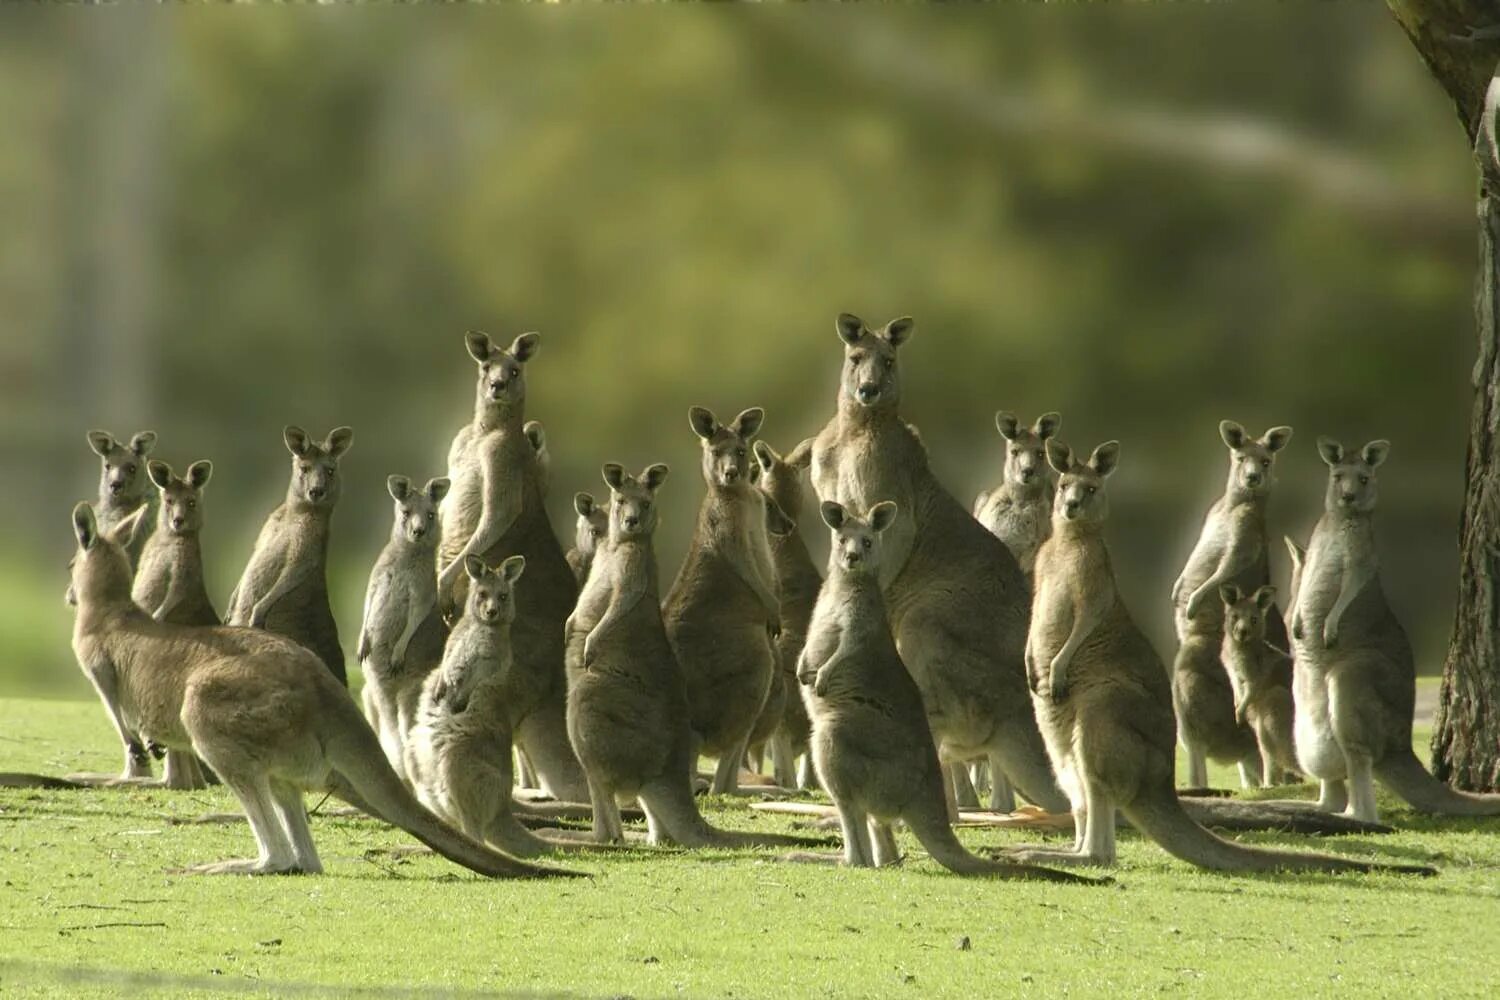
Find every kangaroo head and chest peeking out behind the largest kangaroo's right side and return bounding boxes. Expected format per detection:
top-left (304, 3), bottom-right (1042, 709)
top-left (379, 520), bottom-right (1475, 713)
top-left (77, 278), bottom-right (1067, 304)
top-left (974, 409), bottom-right (1062, 577)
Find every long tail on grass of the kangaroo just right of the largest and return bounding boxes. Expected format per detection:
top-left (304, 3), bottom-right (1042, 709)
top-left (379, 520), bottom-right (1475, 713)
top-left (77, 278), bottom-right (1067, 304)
top-left (1121, 787), bottom-right (1437, 876)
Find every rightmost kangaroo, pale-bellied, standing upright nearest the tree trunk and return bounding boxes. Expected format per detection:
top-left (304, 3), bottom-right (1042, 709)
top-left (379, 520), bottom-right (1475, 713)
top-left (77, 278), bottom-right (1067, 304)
top-left (1292, 438), bottom-right (1500, 822)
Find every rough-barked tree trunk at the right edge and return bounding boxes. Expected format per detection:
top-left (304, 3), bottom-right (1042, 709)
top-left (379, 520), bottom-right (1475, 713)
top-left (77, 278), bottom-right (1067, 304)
top-left (1388, 0), bottom-right (1500, 790)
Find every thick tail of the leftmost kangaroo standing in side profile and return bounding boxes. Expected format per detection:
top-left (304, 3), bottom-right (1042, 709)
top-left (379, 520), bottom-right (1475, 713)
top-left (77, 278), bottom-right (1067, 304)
top-left (326, 699), bottom-right (585, 879)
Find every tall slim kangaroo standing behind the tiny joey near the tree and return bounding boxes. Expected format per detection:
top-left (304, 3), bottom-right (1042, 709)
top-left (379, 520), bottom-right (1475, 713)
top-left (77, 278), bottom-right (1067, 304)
top-left (1172, 420), bottom-right (1292, 789)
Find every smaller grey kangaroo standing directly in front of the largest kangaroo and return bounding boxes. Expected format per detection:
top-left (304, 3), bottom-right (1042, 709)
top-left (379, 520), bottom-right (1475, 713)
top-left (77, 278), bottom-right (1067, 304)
top-left (797, 501), bottom-right (1094, 882)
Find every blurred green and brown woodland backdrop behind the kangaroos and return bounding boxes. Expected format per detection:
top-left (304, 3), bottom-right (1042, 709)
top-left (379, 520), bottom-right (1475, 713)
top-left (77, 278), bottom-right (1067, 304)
top-left (0, 4), bottom-right (1475, 696)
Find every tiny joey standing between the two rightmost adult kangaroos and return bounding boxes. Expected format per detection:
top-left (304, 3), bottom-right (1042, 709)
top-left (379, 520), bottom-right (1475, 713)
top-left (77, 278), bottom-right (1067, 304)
top-left (1220, 583), bottom-right (1298, 789)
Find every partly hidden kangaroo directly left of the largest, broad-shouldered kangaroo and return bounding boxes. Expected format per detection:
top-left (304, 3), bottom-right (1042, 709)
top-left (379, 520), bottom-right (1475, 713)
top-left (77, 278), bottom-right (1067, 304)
top-left (753, 441), bottom-right (824, 789)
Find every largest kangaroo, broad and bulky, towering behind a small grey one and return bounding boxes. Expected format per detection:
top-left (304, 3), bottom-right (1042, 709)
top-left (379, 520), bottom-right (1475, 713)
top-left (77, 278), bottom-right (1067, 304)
top-left (812, 313), bottom-right (1068, 811)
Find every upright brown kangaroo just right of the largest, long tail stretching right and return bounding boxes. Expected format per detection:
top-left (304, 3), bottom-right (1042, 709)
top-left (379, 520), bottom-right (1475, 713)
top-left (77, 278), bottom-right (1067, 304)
top-left (1014, 439), bottom-right (1433, 874)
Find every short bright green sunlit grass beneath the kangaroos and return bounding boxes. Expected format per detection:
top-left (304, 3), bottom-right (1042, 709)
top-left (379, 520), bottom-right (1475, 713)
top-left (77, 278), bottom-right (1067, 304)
top-left (0, 689), bottom-right (1500, 997)
